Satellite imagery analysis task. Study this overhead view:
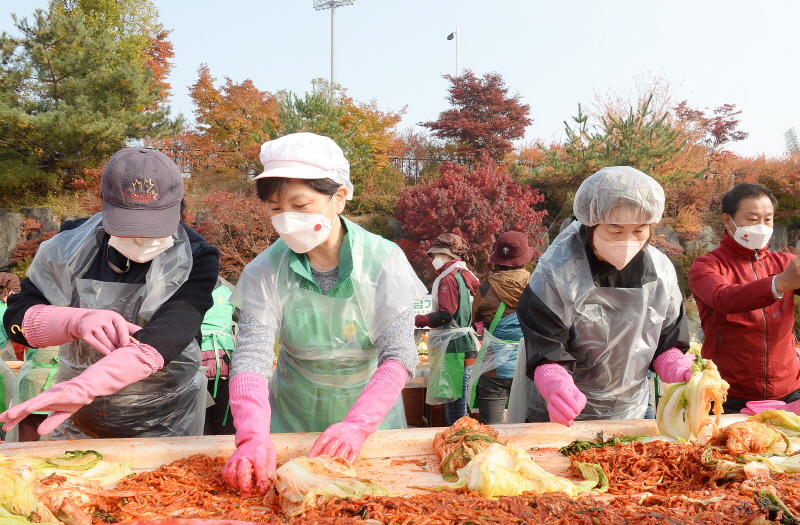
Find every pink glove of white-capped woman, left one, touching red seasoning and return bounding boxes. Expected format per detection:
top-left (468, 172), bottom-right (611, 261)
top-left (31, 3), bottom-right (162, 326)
top-left (222, 372), bottom-right (278, 498)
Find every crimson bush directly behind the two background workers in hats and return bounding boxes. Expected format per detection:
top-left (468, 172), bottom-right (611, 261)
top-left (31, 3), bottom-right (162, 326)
top-left (397, 155), bottom-right (547, 280)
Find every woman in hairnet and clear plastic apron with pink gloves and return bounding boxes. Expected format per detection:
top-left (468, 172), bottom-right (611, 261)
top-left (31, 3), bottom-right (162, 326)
top-left (509, 166), bottom-right (691, 426)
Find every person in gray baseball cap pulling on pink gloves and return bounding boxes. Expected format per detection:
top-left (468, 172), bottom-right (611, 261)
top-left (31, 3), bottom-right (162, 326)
top-left (0, 148), bottom-right (219, 439)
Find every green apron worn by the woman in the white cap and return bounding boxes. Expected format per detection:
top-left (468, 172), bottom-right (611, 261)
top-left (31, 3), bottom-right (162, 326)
top-left (269, 223), bottom-right (411, 432)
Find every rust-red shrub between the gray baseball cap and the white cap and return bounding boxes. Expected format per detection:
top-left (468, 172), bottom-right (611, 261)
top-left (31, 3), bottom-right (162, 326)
top-left (195, 191), bottom-right (278, 282)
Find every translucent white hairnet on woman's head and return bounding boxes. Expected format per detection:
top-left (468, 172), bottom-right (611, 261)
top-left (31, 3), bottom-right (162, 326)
top-left (572, 166), bottom-right (664, 226)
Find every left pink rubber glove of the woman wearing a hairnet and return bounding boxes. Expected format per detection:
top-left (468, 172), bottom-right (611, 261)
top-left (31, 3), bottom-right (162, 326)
top-left (533, 363), bottom-right (586, 427)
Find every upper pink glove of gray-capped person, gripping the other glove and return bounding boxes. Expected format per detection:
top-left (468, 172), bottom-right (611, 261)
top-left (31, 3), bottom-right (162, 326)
top-left (22, 304), bottom-right (142, 355)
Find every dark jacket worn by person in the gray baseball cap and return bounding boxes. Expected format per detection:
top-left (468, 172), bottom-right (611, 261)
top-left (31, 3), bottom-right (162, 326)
top-left (3, 219), bottom-right (219, 365)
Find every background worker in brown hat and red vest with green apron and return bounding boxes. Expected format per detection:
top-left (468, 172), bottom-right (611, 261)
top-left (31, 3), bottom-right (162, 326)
top-left (415, 233), bottom-right (480, 425)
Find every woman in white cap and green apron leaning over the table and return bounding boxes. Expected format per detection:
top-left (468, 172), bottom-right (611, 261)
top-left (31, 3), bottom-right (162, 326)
top-left (222, 133), bottom-right (426, 496)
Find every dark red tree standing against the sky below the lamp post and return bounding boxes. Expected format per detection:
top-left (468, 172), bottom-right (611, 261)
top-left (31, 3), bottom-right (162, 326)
top-left (420, 70), bottom-right (531, 162)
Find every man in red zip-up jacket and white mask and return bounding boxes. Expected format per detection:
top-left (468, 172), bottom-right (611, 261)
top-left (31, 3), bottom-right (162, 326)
top-left (689, 183), bottom-right (800, 413)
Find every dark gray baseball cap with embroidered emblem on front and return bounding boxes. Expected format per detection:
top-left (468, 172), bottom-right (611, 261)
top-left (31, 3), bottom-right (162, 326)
top-left (100, 148), bottom-right (183, 237)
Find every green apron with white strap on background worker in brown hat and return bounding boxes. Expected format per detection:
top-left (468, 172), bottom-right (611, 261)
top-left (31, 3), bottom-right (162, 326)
top-left (426, 272), bottom-right (477, 404)
